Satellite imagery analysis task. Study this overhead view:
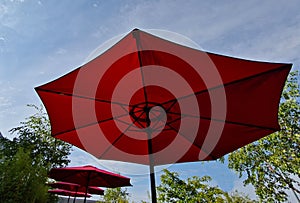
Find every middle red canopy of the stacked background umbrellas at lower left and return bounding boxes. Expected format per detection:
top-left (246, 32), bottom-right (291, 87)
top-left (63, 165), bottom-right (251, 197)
top-left (49, 182), bottom-right (104, 195)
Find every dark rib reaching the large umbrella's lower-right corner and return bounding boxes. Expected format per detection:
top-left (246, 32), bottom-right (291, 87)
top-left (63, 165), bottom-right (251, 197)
top-left (169, 112), bottom-right (277, 131)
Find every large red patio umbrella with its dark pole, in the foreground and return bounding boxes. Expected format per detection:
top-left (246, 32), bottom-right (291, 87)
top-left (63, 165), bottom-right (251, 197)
top-left (36, 29), bottom-right (292, 202)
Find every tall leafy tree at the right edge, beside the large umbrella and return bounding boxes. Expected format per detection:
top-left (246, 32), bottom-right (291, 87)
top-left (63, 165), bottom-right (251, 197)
top-left (228, 72), bottom-right (300, 202)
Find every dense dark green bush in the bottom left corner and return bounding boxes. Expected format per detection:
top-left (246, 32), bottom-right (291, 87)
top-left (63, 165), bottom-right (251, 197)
top-left (0, 148), bottom-right (48, 203)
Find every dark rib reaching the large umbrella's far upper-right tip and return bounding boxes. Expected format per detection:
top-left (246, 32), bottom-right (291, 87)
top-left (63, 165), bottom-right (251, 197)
top-left (162, 65), bottom-right (289, 105)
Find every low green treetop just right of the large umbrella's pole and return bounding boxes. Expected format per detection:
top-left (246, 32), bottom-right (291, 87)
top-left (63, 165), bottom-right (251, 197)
top-left (157, 169), bottom-right (254, 203)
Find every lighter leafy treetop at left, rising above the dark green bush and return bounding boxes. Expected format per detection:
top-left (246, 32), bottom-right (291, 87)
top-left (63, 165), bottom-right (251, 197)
top-left (4, 105), bottom-right (71, 168)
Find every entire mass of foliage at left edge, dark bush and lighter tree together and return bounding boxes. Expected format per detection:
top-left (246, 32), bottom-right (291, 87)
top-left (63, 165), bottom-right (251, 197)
top-left (0, 105), bottom-right (71, 203)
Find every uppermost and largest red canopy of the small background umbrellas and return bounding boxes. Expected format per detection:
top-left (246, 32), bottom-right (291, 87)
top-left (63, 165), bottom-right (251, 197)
top-left (49, 166), bottom-right (131, 187)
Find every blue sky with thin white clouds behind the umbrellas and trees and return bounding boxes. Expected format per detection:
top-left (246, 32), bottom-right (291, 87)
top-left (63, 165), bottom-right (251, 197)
top-left (0, 0), bottom-right (300, 201)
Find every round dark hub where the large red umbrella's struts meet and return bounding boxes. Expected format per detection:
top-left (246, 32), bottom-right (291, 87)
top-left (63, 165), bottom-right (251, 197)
top-left (129, 102), bottom-right (166, 128)
